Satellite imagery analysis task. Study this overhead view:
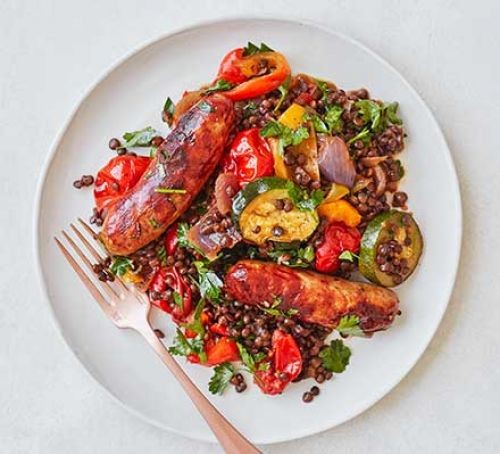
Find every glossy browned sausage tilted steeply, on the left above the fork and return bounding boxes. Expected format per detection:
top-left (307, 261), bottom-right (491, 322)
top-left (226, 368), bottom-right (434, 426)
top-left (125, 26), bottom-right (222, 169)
top-left (100, 94), bottom-right (234, 255)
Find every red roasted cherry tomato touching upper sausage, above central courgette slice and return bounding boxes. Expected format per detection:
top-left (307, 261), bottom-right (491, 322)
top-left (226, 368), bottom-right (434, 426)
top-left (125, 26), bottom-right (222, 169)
top-left (222, 128), bottom-right (274, 186)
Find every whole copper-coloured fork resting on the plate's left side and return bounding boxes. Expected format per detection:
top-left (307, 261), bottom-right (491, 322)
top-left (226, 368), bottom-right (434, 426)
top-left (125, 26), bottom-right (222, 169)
top-left (54, 218), bottom-right (261, 454)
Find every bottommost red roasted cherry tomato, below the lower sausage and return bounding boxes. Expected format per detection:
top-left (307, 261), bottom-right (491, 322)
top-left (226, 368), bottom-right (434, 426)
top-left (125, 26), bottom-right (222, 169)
top-left (255, 329), bottom-right (302, 395)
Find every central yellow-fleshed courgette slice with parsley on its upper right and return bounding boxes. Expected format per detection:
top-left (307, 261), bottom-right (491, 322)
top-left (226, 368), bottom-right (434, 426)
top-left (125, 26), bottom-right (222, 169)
top-left (233, 177), bottom-right (319, 245)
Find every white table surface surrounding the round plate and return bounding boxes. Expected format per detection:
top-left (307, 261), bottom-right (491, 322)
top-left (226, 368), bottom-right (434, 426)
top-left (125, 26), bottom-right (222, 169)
top-left (0, 0), bottom-right (500, 454)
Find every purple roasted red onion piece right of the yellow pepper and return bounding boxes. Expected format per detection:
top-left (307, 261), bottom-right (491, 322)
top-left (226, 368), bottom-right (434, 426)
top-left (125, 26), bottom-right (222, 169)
top-left (318, 134), bottom-right (356, 188)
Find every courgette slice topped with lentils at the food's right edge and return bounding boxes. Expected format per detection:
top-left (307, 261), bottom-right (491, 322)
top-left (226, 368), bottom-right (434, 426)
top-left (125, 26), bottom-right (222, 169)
top-left (359, 210), bottom-right (423, 287)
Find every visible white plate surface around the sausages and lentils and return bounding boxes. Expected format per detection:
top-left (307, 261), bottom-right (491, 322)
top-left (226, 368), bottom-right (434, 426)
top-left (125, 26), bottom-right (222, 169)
top-left (35, 19), bottom-right (461, 443)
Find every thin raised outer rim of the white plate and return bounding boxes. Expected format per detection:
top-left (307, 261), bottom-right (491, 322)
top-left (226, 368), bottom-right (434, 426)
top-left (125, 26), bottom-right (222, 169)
top-left (32, 13), bottom-right (463, 445)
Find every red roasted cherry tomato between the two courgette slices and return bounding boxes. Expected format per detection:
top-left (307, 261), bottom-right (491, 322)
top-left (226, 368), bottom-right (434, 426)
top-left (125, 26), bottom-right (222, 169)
top-left (316, 222), bottom-right (361, 273)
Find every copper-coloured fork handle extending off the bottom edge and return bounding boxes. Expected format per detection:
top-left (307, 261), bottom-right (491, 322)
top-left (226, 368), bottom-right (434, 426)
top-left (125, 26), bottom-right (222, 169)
top-left (140, 326), bottom-right (261, 454)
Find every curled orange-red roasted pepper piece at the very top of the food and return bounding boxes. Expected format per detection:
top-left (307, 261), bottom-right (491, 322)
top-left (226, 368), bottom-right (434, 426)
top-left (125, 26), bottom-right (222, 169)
top-left (216, 48), bottom-right (290, 101)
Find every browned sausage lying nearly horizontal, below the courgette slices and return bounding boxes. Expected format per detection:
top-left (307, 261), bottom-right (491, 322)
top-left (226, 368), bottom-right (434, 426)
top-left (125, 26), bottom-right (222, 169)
top-left (224, 260), bottom-right (399, 334)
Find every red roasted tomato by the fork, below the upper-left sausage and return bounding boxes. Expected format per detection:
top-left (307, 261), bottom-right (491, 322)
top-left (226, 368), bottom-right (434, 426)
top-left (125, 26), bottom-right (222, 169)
top-left (149, 266), bottom-right (193, 323)
